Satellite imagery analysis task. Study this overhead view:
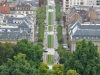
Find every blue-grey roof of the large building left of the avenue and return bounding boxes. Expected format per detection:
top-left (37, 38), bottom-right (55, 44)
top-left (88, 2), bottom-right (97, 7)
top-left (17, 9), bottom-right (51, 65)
top-left (0, 14), bottom-right (32, 40)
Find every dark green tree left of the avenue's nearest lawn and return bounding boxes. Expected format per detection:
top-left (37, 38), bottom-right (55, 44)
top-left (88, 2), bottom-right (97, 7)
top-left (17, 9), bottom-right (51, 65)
top-left (17, 39), bottom-right (43, 65)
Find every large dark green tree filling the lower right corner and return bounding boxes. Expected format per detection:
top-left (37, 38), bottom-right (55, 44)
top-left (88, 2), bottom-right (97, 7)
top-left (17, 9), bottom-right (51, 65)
top-left (64, 40), bottom-right (100, 75)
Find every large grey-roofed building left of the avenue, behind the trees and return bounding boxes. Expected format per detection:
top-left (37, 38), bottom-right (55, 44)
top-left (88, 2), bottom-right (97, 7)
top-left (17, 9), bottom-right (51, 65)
top-left (0, 15), bottom-right (34, 43)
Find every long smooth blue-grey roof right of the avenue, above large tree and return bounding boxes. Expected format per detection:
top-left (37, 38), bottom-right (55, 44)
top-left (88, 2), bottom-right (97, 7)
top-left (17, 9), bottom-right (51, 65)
top-left (69, 21), bottom-right (100, 38)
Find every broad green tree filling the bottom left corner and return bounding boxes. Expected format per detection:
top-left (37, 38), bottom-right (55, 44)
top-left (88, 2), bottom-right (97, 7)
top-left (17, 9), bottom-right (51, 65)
top-left (0, 53), bottom-right (38, 75)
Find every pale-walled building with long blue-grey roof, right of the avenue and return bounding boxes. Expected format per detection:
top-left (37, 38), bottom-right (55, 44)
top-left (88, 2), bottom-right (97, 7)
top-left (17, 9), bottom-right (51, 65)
top-left (69, 21), bottom-right (100, 51)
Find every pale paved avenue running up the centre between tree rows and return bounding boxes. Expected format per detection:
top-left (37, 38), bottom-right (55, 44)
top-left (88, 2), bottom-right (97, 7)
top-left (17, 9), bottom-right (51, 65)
top-left (43, 0), bottom-right (59, 69)
